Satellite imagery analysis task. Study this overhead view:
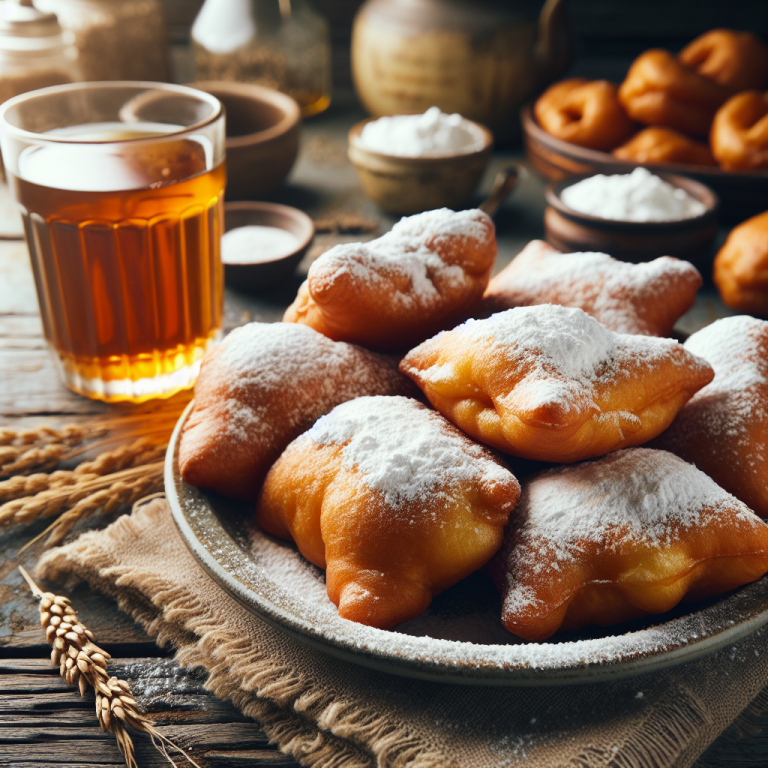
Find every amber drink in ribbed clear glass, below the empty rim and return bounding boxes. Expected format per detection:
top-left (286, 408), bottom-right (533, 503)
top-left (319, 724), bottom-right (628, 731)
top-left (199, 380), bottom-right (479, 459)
top-left (8, 125), bottom-right (226, 402)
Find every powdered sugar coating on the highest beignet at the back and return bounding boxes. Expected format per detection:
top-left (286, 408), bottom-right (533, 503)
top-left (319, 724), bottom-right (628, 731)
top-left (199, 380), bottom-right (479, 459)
top-left (308, 208), bottom-right (495, 309)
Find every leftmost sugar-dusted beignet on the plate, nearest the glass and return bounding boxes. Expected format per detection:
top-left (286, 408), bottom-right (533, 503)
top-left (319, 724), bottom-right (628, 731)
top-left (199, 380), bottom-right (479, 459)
top-left (179, 323), bottom-right (418, 500)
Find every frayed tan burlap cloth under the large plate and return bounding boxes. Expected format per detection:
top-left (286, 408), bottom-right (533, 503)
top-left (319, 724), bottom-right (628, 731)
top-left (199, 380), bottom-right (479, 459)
top-left (38, 499), bottom-right (768, 768)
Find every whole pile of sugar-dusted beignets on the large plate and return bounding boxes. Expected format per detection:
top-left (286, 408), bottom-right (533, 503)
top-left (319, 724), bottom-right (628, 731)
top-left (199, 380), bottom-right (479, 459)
top-left (179, 210), bottom-right (768, 641)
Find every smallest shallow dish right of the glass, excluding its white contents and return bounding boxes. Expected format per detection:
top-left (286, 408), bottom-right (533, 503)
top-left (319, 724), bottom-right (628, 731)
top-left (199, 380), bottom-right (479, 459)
top-left (224, 202), bottom-right (315, 291)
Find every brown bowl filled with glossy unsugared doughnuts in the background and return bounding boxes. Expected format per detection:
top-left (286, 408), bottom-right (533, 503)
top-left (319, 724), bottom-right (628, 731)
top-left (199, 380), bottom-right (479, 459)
top-left (521, 30), bottom-right (768, 222)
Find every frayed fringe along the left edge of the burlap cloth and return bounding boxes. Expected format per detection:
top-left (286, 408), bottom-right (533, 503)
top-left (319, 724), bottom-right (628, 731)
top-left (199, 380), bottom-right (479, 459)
top-left (36, 499), bottom-right (450, 768)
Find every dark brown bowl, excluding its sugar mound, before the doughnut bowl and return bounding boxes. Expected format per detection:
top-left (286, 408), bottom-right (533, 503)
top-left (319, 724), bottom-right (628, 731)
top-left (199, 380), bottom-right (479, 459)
top-left (544, 171), bottom-right (719, 262)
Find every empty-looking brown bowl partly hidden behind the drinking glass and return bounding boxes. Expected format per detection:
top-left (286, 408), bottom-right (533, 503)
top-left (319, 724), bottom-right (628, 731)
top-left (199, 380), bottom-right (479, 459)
top-left (190, 81), bottom-right (301, 200)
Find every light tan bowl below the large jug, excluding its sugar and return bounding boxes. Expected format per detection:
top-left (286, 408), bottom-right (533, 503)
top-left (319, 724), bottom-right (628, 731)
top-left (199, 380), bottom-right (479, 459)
top-left (348, 118), bottom-right (493, 216)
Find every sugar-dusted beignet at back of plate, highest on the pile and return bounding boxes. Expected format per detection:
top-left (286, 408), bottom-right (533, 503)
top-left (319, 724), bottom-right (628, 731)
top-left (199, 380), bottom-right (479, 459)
top-left (283, 208), bottom-right (496, 351)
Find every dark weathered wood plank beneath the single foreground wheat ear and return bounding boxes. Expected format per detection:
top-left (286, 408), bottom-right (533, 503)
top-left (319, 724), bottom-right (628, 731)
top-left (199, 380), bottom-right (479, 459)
top-left (0, 658), bottom-right (296, 768)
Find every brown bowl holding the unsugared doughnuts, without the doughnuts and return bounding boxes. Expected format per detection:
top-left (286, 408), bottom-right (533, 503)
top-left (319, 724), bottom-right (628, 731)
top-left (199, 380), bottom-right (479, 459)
top-left (521, 107), bottom-right (768, 223)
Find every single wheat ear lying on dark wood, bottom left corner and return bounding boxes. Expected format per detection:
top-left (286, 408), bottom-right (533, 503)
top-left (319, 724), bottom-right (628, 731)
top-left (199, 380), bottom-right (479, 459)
top-left (19, 566), bottom-right (200, 768)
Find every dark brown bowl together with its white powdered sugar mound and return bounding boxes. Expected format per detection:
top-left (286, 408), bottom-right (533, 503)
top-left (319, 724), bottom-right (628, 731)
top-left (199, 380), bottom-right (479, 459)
top-left (544, 168), bottom-right (719, 262)
